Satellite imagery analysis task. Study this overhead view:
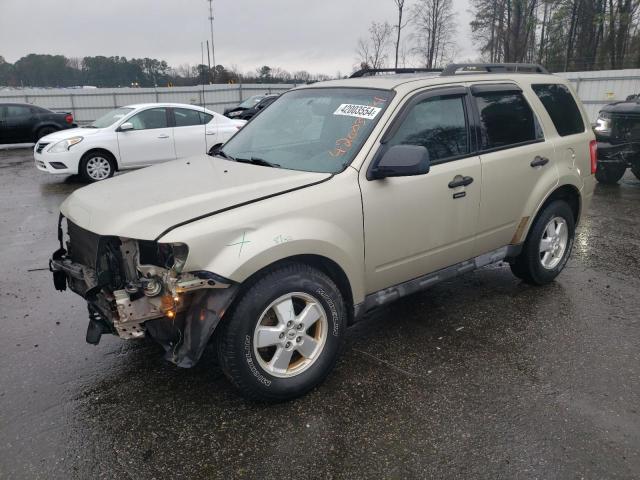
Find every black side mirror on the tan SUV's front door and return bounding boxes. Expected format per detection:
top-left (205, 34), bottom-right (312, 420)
top-left (367, 145), bottom-right (431, 180)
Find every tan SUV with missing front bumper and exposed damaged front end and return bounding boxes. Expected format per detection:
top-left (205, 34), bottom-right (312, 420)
top-left (50, 64), bottom-right (596, 401)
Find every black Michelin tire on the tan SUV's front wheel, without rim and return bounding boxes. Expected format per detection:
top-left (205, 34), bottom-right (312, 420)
top-left (217, 263), bottom-right (347, 402)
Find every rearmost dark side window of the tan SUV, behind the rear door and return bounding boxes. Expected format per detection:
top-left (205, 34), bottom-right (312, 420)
top-left (531, 83), bottom-right (584, 137)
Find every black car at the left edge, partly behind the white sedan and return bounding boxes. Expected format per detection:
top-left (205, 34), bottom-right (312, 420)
top-left (0, 103), bottom-right (77, 144)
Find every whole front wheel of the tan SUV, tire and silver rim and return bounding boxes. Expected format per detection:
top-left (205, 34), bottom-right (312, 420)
top-left (218, 263), bottom-right (346, 402)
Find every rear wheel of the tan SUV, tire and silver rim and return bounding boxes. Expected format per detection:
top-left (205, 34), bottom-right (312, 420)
top-left (511, 200), bottom-right (575, 285)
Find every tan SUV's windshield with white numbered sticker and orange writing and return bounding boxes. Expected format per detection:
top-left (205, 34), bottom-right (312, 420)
top-left (222, 88), bottom-right (392, 173)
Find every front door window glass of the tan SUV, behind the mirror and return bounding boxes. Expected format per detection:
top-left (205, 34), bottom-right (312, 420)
top-left (388, 96), bottom-right (469, 162)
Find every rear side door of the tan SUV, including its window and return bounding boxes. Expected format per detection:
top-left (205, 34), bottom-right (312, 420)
top-left (471, 83), bottom-right (558, 255)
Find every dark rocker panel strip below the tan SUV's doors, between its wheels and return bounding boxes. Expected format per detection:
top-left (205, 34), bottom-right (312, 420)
top-left (354, 245), bottom-right (522, 321)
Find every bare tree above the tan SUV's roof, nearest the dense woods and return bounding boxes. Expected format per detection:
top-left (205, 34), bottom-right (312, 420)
top-left (412, 0), bottom-right (457, 68)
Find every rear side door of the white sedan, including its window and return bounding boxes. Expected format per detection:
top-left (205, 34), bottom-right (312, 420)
top-left (172, 108), bottom-right (211, 158)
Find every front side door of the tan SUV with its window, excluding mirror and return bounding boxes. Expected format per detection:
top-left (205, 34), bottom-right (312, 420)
top-left (360, 87), bottom-right (481, 293)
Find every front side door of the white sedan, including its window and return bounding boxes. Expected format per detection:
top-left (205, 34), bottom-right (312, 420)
top-left (116, 107), bottom-right (176, 167)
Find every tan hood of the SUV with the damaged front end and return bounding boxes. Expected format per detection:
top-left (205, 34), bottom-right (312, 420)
top-left (60, 155), bottom-right (331, 240)
